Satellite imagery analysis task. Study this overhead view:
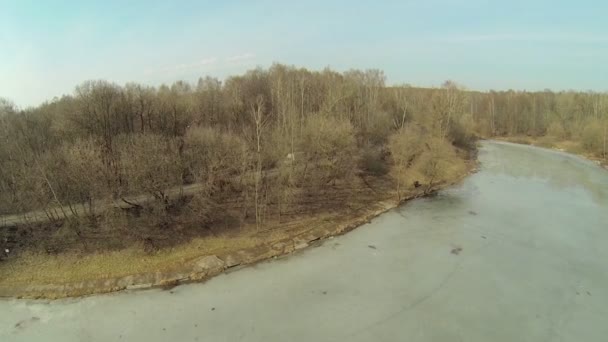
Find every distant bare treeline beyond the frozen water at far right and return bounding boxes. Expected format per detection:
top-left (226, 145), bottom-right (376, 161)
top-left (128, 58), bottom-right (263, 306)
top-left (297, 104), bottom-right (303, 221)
top-left (468, 90), bottom-right (608, 159)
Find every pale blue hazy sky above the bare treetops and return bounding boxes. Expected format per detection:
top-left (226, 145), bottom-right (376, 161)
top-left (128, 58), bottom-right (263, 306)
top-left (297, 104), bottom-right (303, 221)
top-left (0, 0), bottom-right (608, 108)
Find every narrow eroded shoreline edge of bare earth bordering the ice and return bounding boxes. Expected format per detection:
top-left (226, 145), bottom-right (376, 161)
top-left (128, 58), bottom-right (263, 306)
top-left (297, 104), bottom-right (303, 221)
top-left (0, 158), bottom-right (477, 300)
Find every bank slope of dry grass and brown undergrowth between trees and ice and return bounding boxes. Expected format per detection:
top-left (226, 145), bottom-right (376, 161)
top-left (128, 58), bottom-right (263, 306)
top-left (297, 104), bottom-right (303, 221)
top-left (0, 151), bottom-right (474, 298)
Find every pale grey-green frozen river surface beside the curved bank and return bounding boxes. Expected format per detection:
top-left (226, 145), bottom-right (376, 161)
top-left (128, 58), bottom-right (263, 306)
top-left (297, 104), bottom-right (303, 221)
top-left (5, 141), bottom-right (608, 342)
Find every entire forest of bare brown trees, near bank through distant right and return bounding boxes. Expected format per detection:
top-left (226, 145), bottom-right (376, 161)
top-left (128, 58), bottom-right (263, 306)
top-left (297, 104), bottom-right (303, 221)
top-left (0, 64), bottom-right (608, 256)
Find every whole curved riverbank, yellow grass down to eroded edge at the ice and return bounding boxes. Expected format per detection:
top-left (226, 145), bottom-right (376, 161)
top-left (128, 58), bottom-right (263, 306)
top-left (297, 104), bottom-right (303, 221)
top-left (0, 160), bottom-right (476, 299)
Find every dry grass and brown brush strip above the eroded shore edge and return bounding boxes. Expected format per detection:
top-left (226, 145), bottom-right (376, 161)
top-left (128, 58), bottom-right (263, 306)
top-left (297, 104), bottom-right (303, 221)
top-left (0, 171), bottom-right (472, 288)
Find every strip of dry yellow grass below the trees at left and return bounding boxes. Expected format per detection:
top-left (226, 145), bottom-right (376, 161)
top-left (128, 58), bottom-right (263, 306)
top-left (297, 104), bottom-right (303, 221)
top-left (0, 211), bottom-right (338, 286)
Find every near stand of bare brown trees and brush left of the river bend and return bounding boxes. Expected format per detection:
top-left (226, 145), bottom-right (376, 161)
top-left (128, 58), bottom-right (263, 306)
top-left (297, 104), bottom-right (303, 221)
top-left (0, 65), bottom-right (474, 280)
